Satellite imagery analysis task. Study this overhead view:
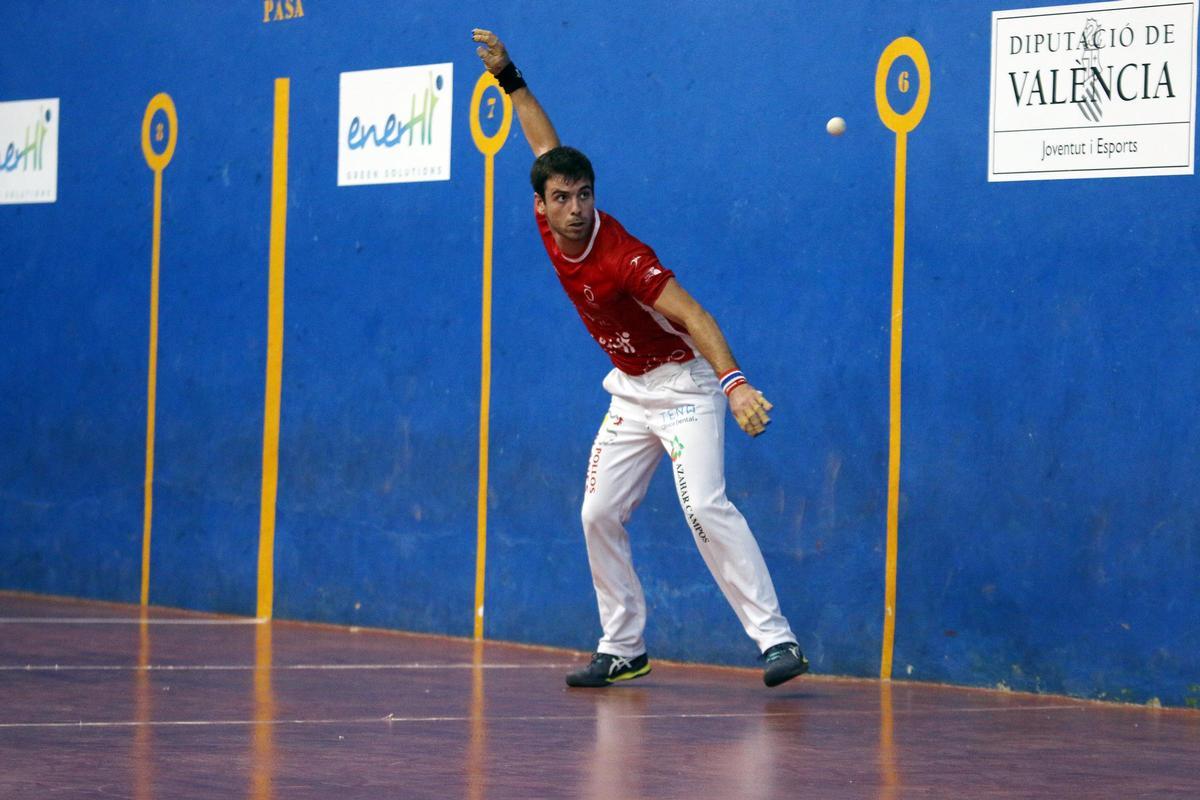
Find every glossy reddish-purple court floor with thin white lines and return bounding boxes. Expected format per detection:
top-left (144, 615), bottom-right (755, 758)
top-left (0, 593), bottom-right (1200, 800)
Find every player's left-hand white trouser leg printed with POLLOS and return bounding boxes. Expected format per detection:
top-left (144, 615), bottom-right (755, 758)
top-left (581, 402), bottom-right (662, 658)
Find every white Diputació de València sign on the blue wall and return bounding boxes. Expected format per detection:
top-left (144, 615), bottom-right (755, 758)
top-left (988, 0), bottom-right (1196, 181)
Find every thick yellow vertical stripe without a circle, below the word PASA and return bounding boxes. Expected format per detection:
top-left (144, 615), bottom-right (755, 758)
top-left (257, 78), bottom-right (292, 619)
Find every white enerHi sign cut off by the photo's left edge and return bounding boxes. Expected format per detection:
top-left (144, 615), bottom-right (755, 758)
top-left (0, 97), bottom-right (59, 204)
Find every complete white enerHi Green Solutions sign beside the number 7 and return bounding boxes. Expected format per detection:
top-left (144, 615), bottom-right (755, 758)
top-left (337, 64), bottom-right (454, 186)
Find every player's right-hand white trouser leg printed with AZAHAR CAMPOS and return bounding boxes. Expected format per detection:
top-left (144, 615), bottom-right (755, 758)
top-left (654, 371), bottom-right (796, 652)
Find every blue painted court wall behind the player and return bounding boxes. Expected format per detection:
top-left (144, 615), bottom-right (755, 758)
top-left (0, 0), bottom-right (1200, 705)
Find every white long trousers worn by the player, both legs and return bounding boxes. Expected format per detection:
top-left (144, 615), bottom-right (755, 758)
top-left (582, 359), bottom-right (796, 658)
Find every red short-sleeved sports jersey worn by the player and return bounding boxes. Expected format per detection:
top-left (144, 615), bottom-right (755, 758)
top-left (534, 210), bottom-right (696, 375)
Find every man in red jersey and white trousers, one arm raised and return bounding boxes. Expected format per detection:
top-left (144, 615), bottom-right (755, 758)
top-left (473, 29), bottom-right (809, 687)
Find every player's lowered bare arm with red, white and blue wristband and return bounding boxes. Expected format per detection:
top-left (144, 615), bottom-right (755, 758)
top-left (654, 278), bottom-right (772, 437)
